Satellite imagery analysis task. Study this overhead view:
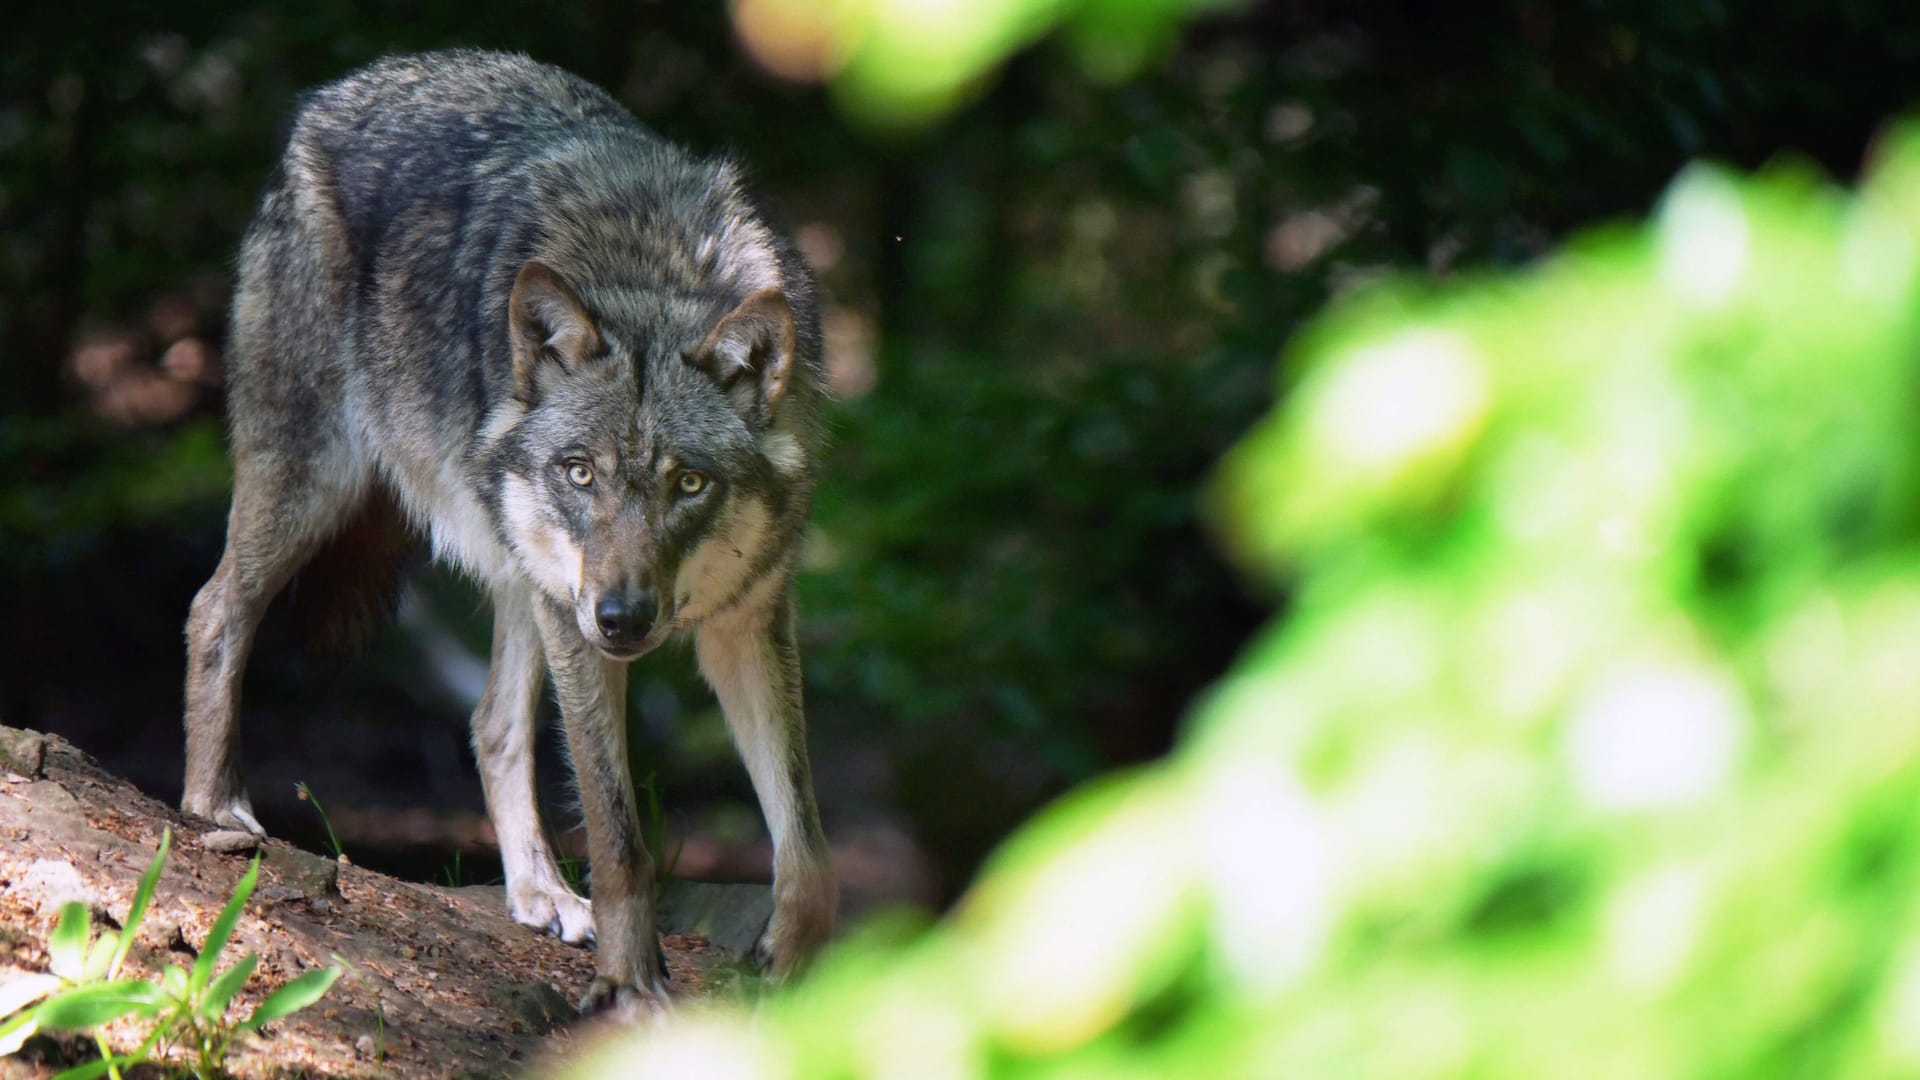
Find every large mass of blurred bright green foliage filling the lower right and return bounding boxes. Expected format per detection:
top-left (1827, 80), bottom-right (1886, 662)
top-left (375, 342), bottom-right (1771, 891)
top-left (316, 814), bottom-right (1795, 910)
top-left (574, 119), bottom-right (1920, 1080)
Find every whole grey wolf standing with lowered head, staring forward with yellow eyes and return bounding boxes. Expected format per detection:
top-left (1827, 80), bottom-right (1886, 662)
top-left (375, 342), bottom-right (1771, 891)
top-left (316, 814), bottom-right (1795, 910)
top-left (182, 50), bottom-right (837, 1017)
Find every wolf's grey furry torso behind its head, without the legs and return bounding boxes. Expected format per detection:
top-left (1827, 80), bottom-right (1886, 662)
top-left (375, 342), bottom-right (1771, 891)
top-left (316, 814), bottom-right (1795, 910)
top-left (228, 50), bottom-right (824, 653)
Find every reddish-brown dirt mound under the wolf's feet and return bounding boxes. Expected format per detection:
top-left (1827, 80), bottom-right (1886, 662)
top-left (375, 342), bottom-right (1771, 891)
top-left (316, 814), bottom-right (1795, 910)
top-left (0, 728), bottom-right (766, 1078)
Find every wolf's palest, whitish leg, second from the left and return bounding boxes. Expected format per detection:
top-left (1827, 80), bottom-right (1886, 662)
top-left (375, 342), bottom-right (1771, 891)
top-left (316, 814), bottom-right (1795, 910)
top-left (472, 588), bottom-right (593, 944)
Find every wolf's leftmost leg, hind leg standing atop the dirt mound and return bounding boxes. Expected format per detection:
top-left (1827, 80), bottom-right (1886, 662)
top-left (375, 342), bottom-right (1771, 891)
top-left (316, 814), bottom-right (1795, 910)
top-left (180, 445), bottom-right (367, 836)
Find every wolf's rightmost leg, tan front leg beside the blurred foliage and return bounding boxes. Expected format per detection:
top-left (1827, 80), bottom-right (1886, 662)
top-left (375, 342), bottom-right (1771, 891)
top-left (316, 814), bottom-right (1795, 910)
top-left (695, 588), bottom-right (839, 976)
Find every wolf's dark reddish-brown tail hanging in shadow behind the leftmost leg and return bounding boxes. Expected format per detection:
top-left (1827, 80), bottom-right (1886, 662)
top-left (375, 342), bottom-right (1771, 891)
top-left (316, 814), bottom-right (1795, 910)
top-left (286, 484), bottom-right (415, 657)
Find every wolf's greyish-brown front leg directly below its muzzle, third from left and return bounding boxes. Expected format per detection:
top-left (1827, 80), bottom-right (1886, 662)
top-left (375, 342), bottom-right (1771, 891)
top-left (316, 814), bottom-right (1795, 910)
top-left (534, 600), bottom-right (668, 1020)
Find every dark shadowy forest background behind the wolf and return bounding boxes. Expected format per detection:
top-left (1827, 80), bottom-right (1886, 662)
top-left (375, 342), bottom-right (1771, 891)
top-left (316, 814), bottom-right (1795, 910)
top-left (0, 0), bottom-right (1920, 903)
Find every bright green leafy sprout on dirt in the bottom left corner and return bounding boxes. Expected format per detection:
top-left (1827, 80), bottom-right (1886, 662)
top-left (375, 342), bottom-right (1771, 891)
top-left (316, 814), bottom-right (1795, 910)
top-left (0, 830), bottom-right (340, 1080)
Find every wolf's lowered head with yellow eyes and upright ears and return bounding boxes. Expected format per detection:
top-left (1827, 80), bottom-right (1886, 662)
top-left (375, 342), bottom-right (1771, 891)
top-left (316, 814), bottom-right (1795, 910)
top-left (493, 261), bottom-right (814, 659)
